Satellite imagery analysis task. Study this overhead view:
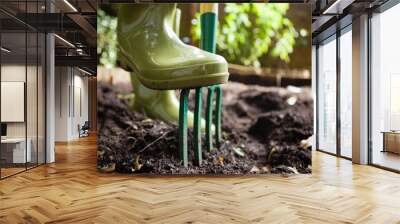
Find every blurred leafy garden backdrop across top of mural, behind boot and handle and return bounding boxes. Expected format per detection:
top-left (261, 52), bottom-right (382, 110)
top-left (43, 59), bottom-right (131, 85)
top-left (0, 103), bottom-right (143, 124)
top-left (97, 3), bottom-right (311, 79)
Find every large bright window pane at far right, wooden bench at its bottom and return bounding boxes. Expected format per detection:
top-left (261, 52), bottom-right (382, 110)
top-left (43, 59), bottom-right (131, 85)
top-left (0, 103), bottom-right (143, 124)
top-left (371, 4), bottom-right (400, 170)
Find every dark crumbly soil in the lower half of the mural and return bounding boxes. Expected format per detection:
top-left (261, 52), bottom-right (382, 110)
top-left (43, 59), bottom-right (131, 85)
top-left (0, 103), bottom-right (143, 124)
top-left (98, 82), bottom-right (313, 174)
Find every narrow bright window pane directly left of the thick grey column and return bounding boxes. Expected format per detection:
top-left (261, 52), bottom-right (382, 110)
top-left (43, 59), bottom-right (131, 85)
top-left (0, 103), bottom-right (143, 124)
top-left (340, 30), bottom-right (352, 158)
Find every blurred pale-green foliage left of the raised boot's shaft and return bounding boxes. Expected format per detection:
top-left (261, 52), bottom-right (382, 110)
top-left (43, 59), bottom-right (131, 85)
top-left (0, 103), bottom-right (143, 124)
top-left (97, 8), bottom-right (117, 68)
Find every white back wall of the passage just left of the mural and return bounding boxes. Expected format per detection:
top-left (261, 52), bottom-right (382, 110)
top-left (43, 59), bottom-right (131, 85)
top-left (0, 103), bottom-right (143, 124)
top-left (55, 67), bottom-right (89, 141)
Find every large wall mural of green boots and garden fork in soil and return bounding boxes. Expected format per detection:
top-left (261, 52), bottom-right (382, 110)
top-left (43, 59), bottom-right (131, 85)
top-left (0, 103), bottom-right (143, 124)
top-left (97, 3), bottom-right (313, 175)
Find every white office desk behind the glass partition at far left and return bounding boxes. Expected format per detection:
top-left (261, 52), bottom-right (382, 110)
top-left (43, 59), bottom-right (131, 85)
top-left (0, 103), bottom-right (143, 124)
top-left (1, 138), bottom-right (32, 163)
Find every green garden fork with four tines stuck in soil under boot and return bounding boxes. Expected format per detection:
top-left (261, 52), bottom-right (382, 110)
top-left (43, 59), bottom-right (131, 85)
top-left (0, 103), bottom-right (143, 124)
top-left (179, 3), bottom-right (222, 167)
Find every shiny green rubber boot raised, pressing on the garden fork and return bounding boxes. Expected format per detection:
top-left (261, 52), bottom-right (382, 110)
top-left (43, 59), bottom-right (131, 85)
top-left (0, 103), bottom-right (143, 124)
top-left (117, 4), bottom-right (229, 90)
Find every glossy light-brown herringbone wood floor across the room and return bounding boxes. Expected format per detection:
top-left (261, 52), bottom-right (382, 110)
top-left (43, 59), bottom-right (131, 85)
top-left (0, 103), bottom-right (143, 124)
top-left (0, 137), bottom-right (400, 224)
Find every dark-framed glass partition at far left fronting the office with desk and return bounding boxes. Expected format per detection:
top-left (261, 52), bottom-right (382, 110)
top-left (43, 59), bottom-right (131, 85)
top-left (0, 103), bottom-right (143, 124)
top-left (0, 0), bottom-right (45, 177)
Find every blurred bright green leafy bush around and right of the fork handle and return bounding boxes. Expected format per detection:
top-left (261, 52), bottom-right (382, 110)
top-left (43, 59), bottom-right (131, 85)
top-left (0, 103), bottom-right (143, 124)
top-left (192, 3), bottom-right (298, 67)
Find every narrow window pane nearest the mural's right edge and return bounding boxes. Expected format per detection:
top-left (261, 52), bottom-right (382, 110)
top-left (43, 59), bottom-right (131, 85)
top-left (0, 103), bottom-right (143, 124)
top-left (318, 39), bottom-right (336, 153)
